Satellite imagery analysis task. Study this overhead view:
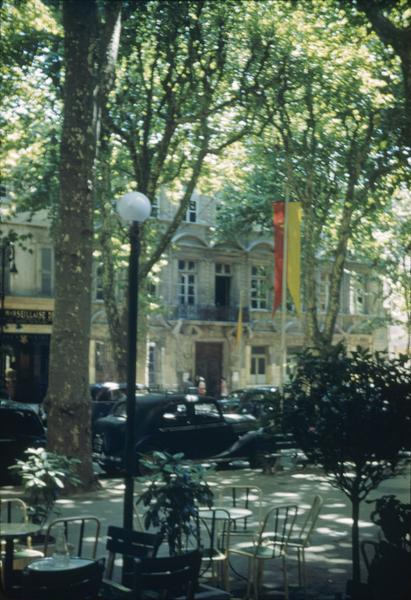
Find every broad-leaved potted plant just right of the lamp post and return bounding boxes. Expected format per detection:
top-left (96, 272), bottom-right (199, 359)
top-left (137, 452), bottom-right (213, 555)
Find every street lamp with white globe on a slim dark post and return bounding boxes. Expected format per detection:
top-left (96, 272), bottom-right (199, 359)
top-left (117, 192), bottom-right (151, 531)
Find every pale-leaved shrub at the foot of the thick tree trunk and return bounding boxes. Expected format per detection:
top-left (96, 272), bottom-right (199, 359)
top-left (9, 448), bottom-right (81, 524)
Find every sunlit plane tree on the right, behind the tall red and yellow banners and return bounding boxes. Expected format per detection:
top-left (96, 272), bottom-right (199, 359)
top-left (214, 1), bottom-right (407, 351)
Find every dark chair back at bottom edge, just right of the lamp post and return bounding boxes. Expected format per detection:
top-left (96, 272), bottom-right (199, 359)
top-left (134, 550), bottom-right (201, 600)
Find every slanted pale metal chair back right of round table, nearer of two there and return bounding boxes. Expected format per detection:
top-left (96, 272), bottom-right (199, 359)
top-left (255, 504), bottom-right (298, 558)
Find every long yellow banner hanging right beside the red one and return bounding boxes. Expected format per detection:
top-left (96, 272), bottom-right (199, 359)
top-left (287, 202), bottom-right (302, 315)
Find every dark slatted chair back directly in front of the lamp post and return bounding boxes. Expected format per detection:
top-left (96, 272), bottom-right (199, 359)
top-left (106, 525), bottom-right (161, 579)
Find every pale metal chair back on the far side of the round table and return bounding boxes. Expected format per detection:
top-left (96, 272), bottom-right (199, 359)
top-left (218, 485), bottom-right (263, 535)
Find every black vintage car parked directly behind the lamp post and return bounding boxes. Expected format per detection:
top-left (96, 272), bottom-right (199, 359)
top-left (93, 394), bottom-right (265, 472)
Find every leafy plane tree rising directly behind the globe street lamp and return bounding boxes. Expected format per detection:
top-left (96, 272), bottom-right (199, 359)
top-left (97, 0), bottom-right (273, 377)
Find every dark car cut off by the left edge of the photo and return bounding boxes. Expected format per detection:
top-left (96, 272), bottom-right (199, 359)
top-left (0, 400), bottom-right (46, 484)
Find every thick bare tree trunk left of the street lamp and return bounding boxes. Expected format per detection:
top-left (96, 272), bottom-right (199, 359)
top-left (47, 0), bottom-right (97, 488)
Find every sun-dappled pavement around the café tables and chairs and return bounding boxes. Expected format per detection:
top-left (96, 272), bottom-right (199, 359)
top-left (0, 466), bottom-right (411, 600)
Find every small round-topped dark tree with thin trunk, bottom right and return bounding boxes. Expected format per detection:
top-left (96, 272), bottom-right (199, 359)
top-left (285, 345), bottom-right (411, 600)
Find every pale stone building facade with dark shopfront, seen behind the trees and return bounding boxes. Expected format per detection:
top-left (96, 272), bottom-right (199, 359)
top-left (1, 192), bottom-right (387, 399)
